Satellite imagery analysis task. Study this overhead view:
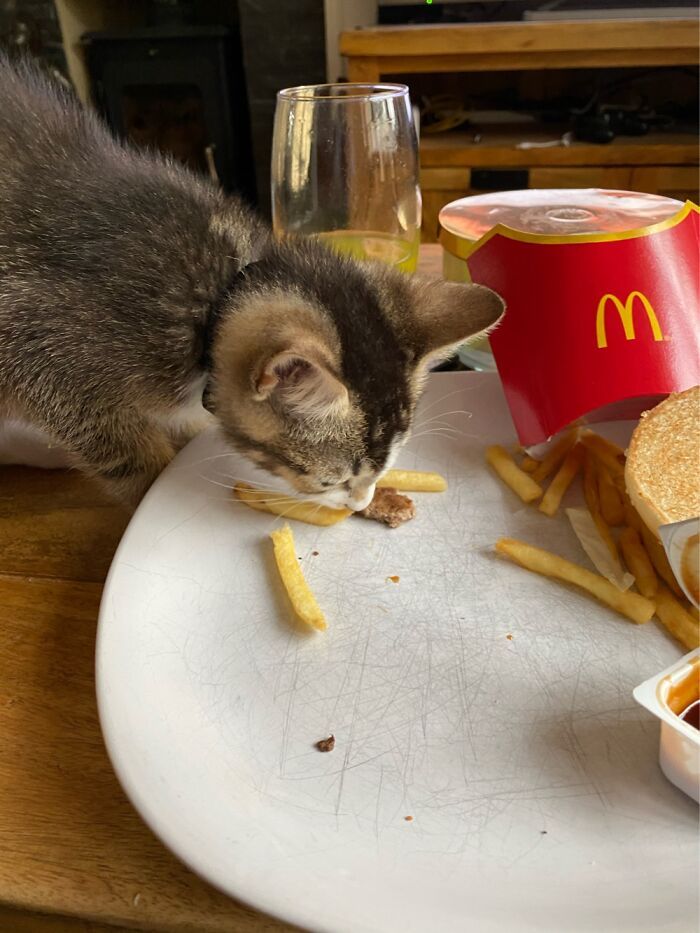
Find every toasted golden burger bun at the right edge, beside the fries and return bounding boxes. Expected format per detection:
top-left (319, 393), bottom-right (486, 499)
top-left (625, 386), bottom-right (700, 534)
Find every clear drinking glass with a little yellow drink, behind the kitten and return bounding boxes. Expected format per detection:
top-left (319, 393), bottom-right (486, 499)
top-left (272, 83), bottom-right (421, 272)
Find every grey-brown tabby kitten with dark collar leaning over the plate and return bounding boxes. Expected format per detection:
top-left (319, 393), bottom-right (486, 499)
top-left (0, 60), bottom-right (504, 510)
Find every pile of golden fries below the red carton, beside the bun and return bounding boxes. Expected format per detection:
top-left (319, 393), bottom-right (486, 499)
top-left (486, 429), bottom-right (700, 650)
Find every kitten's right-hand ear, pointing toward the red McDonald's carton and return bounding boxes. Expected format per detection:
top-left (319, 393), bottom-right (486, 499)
top-left (413, 277), bottom-right (505, 362)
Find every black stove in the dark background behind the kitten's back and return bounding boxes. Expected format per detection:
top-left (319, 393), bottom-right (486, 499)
top-left (82, 23), bottom-right (255, 202)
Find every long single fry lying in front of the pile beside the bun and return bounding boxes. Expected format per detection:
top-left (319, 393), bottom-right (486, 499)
top-left (496, 538), bottom-right (655, 625)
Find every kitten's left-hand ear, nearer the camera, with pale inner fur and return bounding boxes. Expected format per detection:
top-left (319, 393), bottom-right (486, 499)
top-left (254, 347), bottom-right (348, 421)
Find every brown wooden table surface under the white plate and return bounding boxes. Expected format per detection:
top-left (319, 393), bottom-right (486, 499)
top-left (0, 247), bottom-right (439, 933)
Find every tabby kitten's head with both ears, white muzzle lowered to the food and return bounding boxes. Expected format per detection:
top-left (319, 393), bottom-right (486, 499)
top-left (210, 241), bottom-right (504, 509)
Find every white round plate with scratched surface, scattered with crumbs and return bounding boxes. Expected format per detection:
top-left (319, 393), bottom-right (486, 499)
top-left (97, 374), bottom-right (698, 933)
